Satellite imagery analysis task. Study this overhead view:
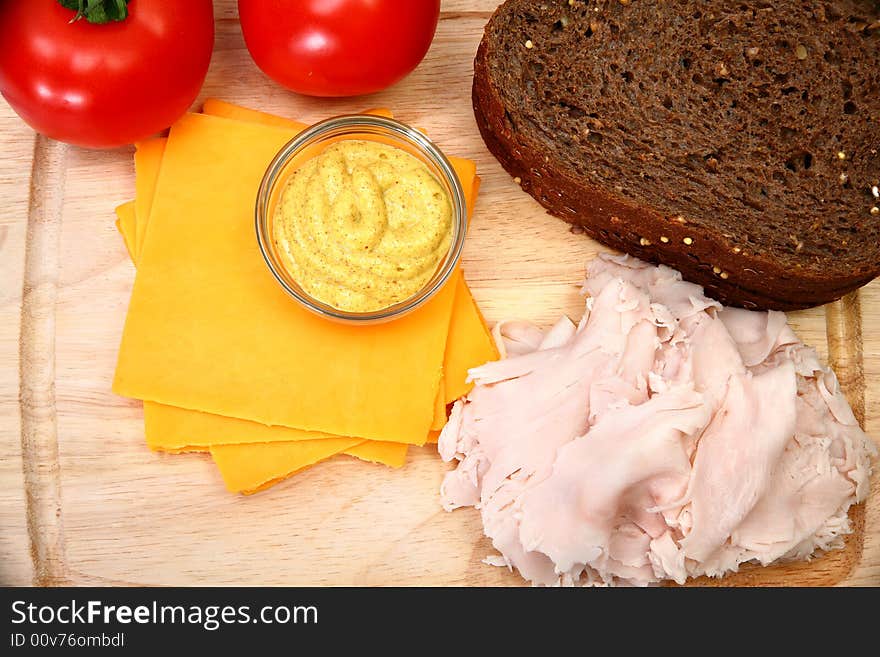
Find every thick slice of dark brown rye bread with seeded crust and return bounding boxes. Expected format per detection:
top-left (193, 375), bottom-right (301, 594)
top-left (473, 0), bottom-right (880, 310)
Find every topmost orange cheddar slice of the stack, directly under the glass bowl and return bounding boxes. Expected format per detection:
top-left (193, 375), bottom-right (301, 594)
top-left (114, 114), bottom-right (455, 444)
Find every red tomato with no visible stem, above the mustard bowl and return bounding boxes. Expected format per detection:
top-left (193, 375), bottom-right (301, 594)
top-left (238, 0), bottom-right (440, 96)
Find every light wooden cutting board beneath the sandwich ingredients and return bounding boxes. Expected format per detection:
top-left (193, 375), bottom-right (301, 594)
top-left (0, 0), bottom-right (880, 585)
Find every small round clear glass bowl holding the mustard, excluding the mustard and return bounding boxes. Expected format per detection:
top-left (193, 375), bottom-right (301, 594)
top-left (256, 114), bottom-right (467, 324)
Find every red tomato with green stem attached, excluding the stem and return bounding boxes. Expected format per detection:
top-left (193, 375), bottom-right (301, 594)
top-left (0, 0), bottom-right (214, 148)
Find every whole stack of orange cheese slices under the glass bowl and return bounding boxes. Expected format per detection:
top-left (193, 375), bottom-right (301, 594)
top-left (114, 100), bottom-right (497, 493)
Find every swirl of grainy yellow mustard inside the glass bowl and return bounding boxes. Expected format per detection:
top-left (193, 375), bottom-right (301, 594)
top-left (273, 140), bottom-right (452, 312)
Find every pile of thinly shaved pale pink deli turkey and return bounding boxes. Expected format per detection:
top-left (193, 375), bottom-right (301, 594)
top-left (439, 256), bottom-right (877, 585)
